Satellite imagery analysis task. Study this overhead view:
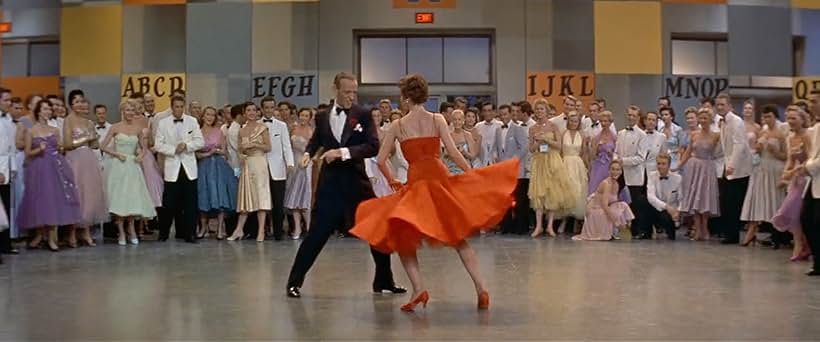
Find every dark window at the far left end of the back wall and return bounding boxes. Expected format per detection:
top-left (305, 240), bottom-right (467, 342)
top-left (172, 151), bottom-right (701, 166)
top-left (2, 41), bottom-right (60, 77)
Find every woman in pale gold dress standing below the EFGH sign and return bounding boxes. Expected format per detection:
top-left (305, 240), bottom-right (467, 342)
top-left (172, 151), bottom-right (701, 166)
top-left (228, 102), bottom-right (273, 242)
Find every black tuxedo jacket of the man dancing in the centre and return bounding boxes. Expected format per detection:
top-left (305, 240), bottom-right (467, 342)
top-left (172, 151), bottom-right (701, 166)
top-left (306, 105), bottom-right (379, 216)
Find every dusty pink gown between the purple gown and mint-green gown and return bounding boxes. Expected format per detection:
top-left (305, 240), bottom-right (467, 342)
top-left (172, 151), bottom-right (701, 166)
top-left (65, 122), bottom-right (110, 226)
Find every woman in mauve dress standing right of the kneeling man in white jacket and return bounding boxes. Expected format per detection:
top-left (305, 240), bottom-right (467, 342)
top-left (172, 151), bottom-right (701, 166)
top-left (678, 108), bottom-right (720, 240)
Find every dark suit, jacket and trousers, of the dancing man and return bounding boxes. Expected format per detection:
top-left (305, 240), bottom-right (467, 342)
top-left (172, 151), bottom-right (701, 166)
top-left (287, 105), bottom-right (394, 288)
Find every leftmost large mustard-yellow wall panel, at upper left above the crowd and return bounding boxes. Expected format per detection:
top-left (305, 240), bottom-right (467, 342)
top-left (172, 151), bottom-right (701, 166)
top-left (60, 5), bottom-right (122, 76)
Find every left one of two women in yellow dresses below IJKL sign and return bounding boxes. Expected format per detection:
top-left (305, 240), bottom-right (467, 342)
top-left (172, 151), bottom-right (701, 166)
top-left (528, 99), bottom-right (578, 238)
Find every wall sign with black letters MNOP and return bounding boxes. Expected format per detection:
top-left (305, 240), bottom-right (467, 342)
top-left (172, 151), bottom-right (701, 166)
top-left (661, 75), bottom-right (729, 123)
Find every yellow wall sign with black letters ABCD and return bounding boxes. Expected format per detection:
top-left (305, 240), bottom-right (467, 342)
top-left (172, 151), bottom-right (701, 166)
top-left (120, 74), bottom-right (185, 111)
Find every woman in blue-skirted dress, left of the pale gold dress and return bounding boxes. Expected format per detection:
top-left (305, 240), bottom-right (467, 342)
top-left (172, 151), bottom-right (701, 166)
top-left (196, 107), bottom-right (238, 240)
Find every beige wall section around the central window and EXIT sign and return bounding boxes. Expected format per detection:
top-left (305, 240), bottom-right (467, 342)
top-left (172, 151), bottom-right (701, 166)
top-left (319, 0), bottom-right (540, 102)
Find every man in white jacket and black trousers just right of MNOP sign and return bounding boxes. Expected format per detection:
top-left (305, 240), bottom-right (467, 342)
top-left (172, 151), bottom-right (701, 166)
top-left (715, 94), bottom-right (752, 244)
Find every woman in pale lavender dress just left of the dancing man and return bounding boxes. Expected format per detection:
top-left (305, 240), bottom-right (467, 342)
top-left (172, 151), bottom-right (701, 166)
top-left (284, 108), bottom-right (313, 240)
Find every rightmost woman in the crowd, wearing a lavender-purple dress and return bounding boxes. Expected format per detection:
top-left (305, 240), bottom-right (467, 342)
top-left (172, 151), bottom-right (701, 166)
top-left (772, 106), bottom-right (812, 261)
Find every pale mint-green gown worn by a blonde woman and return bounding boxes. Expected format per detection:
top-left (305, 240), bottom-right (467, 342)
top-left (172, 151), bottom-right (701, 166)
top-left (104, 133), bottom-right (157, 218)
